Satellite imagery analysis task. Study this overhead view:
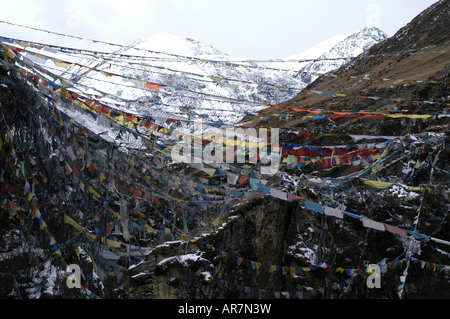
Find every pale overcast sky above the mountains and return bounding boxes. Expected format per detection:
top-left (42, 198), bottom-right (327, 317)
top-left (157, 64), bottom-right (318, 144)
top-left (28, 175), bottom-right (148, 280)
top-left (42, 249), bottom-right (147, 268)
top-left (0, 0), bottom-right (436, 59)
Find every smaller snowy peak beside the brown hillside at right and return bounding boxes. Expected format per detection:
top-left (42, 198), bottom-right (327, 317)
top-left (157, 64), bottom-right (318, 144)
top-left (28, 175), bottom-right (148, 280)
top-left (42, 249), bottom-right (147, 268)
top-left (268, 27), bottom-right (388, 84)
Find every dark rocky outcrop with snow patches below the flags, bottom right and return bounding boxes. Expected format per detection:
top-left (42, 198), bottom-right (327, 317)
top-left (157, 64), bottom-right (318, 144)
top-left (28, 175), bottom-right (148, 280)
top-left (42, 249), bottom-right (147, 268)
top-left (125, 188), bottom-right (449, 299)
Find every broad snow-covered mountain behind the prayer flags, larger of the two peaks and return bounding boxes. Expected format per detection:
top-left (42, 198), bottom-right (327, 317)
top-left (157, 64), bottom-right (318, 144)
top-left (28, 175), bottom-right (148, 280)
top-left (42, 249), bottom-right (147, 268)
top-left (65, 34), bottom-right (304, 124)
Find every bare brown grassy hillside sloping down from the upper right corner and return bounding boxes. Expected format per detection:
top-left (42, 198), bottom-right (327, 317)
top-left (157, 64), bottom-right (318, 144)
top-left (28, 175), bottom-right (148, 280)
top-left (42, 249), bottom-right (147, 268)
top-left (242, 1), bottom-right (450, 135)
